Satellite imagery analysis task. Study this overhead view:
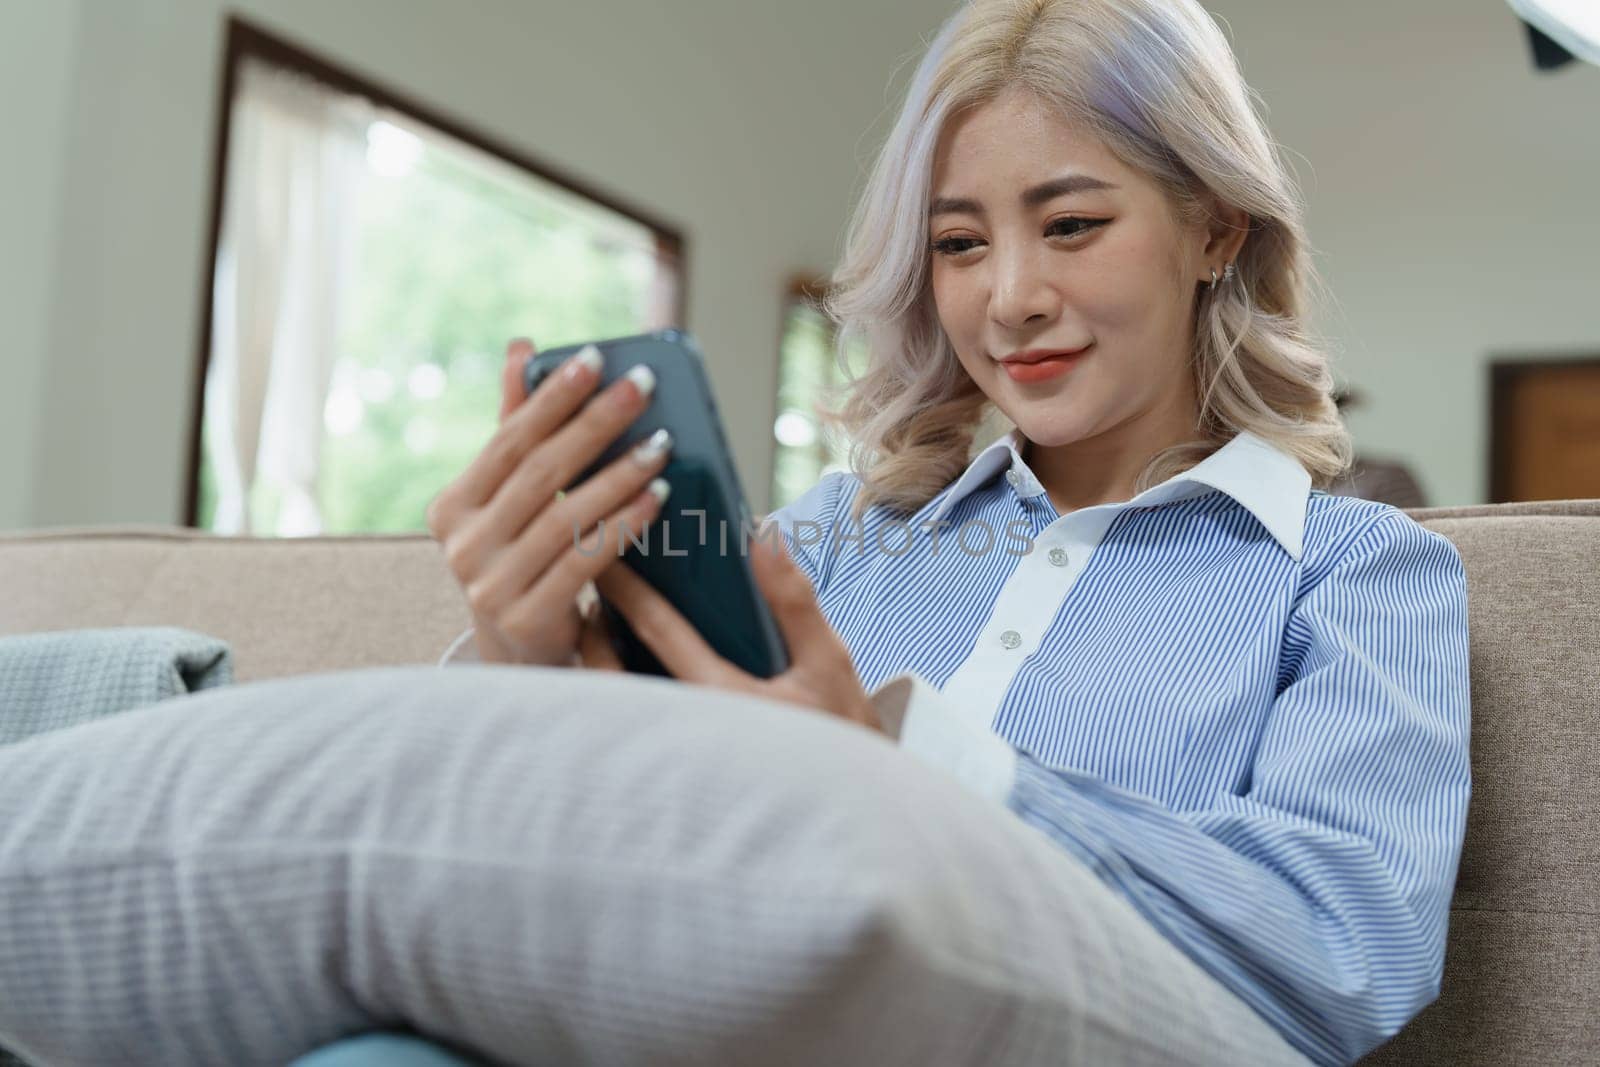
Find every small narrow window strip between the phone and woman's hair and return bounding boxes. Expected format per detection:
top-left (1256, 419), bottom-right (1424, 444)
top-left (773, 282), bottom-right (866, 510)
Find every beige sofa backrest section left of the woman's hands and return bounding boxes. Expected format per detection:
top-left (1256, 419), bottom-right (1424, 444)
top-left (0, 526), bottom-right (472, 681)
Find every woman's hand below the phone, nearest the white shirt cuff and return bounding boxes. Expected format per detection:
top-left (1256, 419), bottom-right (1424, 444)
top-left (595, 531), bottom-right (885, 734)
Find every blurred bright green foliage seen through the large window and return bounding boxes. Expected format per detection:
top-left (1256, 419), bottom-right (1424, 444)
top-left (198, 119), bottom-right (669, 534)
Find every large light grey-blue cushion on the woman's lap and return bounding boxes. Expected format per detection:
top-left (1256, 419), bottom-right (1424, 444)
top-left (0, 665), bottom-right (1304, 1067)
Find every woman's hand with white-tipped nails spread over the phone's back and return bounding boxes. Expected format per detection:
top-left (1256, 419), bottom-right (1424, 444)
top-left (427, 339), bottom-right (670, 665)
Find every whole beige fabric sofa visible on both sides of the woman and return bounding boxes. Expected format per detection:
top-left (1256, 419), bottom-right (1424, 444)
top-left (0, 501), bottom-right (1600, 1065)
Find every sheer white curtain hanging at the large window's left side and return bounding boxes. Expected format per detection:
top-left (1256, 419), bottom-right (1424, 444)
top-left (205, 59), bottom-right (371, 536)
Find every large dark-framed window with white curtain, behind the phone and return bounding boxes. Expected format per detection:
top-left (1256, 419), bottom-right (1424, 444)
top-left (187, 19), bottom-right (683, 536)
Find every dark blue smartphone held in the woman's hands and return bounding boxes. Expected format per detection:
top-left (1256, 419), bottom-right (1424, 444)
top-left (522, 330), bottom-right (789, 678)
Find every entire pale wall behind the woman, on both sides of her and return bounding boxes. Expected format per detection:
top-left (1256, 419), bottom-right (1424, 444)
top-left (0, 0), bottom-right (1600, 525)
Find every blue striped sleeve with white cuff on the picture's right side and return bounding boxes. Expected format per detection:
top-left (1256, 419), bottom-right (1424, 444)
top-left (874, 512), bottom-right (1470, 1064)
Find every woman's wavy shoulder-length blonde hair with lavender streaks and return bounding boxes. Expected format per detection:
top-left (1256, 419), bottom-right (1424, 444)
top-left (821, 0), bottom-right (1350, 518)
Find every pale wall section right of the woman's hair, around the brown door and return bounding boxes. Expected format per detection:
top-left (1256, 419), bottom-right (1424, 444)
top-left (1208, 0), bottom-right (1600, 504)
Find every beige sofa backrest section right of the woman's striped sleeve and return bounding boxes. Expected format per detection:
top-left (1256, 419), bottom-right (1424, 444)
top-left (1363, 501), bottom-right (1600, 1065)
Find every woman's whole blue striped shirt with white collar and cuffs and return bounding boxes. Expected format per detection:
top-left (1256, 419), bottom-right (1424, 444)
top-left (771, 432), bottom-right (1470, 1064)
